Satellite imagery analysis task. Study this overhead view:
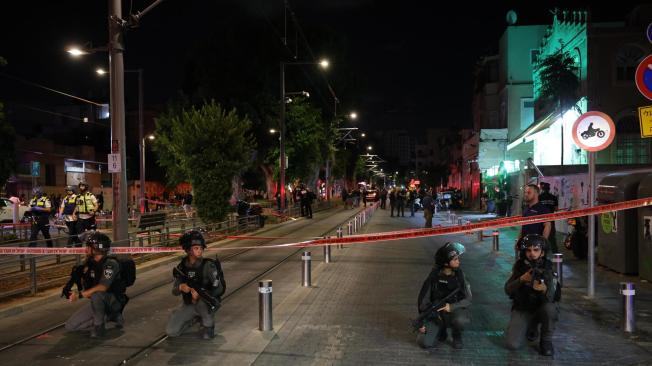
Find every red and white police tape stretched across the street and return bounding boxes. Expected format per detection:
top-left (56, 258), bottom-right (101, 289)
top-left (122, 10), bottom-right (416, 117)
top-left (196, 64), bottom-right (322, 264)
top-left (0, 197), bottom-right (652, 255)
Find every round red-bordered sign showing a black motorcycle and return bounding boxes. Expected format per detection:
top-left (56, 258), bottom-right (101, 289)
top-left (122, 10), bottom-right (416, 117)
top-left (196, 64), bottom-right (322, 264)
top-left (573, 111), bottom-right (616, 151)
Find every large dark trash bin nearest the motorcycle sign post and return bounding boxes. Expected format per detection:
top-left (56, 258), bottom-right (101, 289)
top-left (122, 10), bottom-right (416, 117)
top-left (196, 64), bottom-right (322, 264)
top-left (596, 173), bottom-right (648, 274)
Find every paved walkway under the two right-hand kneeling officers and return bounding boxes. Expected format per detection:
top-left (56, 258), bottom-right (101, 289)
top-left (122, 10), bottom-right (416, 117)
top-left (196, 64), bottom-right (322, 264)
top-left (247, 210), bottom-right (652, 365)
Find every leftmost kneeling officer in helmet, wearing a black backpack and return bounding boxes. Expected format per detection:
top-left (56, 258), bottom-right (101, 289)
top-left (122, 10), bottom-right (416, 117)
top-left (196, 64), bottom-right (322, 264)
top-left (63, 232), bottom-right (129, 338)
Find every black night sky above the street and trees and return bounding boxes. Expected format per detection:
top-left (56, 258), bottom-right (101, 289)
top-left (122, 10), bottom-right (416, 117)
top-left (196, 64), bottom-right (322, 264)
top-left (0, 0), bottom-right (632, 137)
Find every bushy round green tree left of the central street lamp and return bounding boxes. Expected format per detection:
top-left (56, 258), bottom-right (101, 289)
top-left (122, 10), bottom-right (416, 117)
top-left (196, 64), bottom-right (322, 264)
top-left (153, 101), bottom-right (256, 221)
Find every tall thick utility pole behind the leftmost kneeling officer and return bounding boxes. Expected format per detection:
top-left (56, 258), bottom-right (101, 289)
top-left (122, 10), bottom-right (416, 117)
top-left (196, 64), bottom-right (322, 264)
top-left (109, 0), bottom-right (129, 246)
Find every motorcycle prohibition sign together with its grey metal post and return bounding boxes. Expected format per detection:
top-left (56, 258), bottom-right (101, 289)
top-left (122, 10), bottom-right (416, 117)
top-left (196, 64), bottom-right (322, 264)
top-left (573, 111), bottom-right (616, 298)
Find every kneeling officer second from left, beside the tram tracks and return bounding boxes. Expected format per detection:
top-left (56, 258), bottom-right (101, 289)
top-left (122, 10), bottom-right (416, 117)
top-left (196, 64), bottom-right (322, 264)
top-left (165, 230), bottom-right (225, 339)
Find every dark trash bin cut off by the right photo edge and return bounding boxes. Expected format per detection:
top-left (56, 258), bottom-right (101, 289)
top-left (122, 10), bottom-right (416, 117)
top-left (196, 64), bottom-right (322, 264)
top-left (637, 173), bottom-right (652, 280)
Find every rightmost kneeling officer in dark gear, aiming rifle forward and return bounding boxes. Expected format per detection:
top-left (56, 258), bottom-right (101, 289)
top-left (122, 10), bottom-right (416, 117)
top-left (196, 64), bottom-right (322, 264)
top-left (505, 234), bottom-right (561, 356)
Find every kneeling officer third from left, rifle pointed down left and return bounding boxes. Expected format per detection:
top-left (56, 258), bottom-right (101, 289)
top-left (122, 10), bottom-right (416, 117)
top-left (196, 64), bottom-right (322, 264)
top-left (417, 242), bottom-right (471, 349)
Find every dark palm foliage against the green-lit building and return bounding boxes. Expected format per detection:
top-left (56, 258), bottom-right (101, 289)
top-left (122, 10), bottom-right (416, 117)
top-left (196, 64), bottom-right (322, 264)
top-left (537, 50), bottom-right (581, 113)
